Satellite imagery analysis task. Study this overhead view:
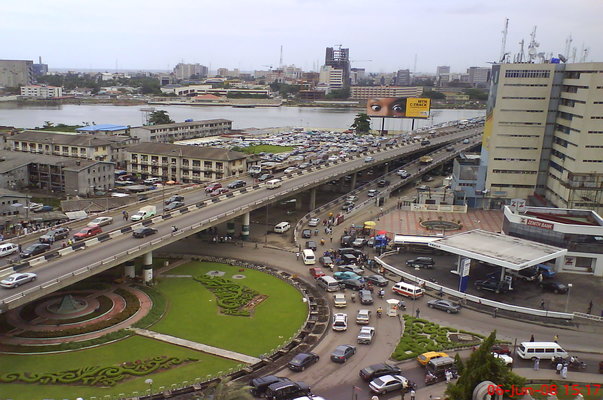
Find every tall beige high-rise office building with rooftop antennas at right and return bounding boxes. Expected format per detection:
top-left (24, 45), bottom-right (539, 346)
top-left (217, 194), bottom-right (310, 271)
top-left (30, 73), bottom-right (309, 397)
top-left (476, 63), bottom-right (603, 213)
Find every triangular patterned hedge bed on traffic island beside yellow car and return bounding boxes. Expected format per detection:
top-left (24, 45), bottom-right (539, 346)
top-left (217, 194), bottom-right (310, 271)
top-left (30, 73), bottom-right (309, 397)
top-left (392, 315), bottom-right (484, 361)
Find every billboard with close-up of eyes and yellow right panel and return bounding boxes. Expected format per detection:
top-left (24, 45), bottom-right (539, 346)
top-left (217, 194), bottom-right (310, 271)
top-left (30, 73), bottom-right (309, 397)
top-left (366, 97), bottom-right (431, 118)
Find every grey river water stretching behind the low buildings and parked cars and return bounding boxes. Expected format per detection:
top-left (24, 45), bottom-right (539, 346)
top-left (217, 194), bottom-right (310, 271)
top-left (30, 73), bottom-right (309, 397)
top-left (0, 103), bottom-right (485, 131)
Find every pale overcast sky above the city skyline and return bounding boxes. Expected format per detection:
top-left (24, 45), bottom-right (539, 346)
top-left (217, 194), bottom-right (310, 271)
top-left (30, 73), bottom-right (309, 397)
top-left (0, 0), bottom-right (603, 72)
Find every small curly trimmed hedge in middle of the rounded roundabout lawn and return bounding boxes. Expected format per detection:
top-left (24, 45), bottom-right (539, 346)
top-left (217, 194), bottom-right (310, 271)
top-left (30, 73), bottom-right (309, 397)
top-left (193, 275), bottom-right (260, 317)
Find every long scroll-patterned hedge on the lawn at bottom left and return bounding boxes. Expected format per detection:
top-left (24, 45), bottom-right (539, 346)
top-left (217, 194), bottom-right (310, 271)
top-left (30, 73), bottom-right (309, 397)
top-left (0, 356), bottom-right (198, 386)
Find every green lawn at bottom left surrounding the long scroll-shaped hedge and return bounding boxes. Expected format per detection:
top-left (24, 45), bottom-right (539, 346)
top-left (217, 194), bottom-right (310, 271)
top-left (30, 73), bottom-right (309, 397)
top-left (0, 337), bottom-right (237, 400)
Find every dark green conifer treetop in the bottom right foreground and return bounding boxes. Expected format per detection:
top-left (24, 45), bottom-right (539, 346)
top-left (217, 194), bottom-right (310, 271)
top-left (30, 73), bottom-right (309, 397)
top-left (446, 331), bottom-right (525, 400)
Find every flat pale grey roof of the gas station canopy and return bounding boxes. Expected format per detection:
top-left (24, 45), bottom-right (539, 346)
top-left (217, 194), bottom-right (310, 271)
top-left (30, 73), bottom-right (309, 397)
top-left (429, 229), bottom-right (567, 271)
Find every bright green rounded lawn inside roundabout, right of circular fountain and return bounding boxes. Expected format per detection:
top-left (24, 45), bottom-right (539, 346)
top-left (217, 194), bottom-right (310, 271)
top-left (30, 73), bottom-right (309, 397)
top-left (149, 262), bottom-right (307, 357)
